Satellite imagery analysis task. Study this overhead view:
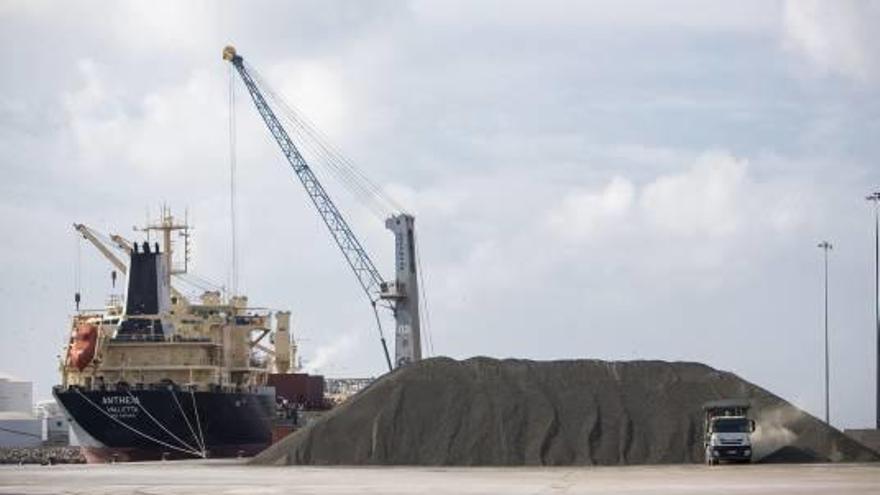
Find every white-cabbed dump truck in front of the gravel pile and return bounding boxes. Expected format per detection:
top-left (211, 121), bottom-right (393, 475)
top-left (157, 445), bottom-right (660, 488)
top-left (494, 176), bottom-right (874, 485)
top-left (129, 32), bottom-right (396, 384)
top-left (703, 399), bottom-right (755, 465)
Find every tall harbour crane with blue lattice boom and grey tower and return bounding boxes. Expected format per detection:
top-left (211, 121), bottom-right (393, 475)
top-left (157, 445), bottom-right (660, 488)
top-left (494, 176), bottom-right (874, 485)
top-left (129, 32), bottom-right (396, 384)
top-left (223, 46), bottom-right (422, 369)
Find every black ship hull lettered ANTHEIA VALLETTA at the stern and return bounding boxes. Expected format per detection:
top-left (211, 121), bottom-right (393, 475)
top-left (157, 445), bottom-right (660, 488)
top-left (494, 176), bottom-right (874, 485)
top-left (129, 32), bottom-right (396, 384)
top-left (53, 387), bottom-right (275, 462)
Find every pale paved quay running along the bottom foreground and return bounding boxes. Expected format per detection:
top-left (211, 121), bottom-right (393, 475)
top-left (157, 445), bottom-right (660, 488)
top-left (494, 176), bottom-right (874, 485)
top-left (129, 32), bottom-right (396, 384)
top-left (0, 460), bottom-right (880, 495)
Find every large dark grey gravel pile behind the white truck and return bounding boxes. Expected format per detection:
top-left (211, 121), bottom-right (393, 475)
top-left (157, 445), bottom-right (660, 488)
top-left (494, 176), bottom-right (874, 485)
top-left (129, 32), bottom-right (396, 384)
top-left (251, 358), bottom-right (878, 466)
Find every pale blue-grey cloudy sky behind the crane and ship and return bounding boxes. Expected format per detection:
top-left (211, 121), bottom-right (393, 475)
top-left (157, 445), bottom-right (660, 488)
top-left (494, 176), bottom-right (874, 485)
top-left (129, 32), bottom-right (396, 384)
top-left (0, 0), bottom-right (880, 428)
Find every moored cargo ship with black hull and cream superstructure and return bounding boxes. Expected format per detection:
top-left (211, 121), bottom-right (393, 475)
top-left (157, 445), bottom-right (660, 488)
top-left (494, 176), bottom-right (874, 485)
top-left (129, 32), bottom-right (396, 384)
top-left (53, 209), bottom-right (329, 462)
